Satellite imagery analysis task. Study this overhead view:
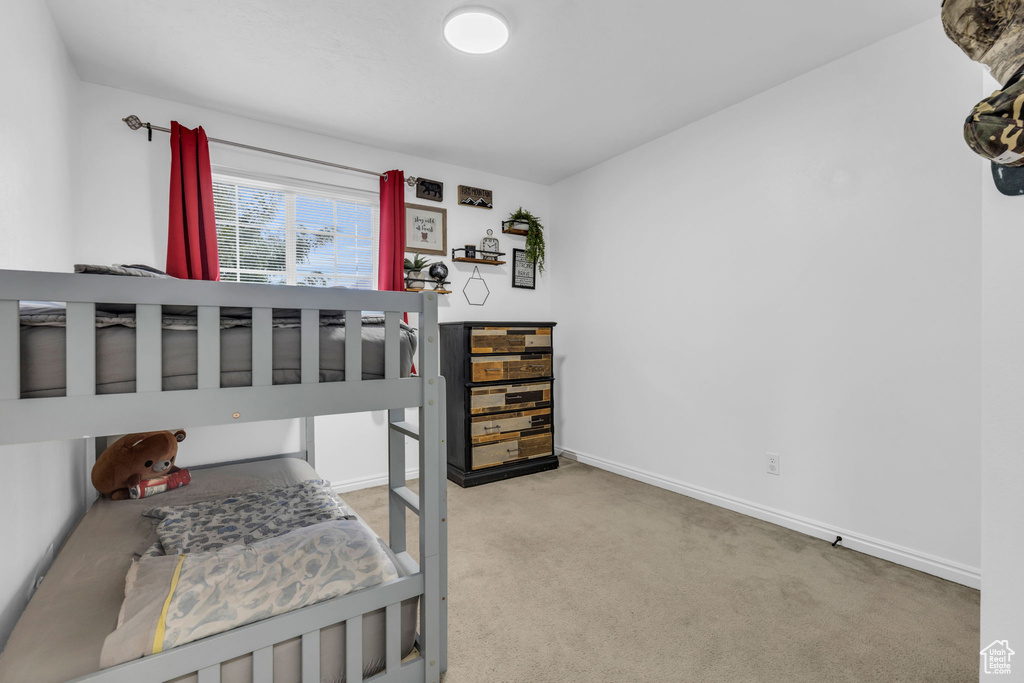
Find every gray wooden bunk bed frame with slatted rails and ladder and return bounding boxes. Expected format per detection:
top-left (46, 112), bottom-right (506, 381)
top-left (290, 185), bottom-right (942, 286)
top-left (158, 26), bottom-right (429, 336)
top-left (0, 270), bottom-right (447, 683)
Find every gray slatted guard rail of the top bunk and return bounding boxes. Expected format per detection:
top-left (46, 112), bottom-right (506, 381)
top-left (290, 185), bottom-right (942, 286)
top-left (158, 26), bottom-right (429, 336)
top-left (0, 270), bottom-right (436, 443)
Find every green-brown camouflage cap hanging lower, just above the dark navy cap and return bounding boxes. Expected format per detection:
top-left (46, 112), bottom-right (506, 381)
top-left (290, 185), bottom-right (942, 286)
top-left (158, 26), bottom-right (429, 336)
top-left (964, 69), bottom-right (1024, 166)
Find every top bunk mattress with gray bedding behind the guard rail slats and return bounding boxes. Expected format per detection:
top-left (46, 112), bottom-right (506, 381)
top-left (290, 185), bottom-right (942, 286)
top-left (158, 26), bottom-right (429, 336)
top-left (19, 302), bottom-right (416, 398)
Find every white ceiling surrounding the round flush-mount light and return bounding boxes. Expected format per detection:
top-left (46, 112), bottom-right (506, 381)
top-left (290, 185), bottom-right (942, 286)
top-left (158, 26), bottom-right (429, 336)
top-left (48, 0), bottom-right (939, 183)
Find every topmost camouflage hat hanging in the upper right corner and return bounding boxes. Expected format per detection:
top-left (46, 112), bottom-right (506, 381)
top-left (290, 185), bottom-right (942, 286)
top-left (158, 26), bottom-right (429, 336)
top-left (942, 0), bottom-right (1024, 87)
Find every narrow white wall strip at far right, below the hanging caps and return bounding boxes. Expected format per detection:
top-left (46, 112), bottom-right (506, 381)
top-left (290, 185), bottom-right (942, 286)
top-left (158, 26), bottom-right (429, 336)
top-left (981, 76), bottom-right (1024, 681)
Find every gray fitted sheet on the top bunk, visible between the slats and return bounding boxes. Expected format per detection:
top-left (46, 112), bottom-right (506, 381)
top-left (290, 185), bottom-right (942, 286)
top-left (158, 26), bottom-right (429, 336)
top-left (20, 316), bottom-right (416, 398)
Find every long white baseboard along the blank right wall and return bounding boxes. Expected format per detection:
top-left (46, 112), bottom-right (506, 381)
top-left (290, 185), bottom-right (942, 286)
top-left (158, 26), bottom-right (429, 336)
top-left (555, 446), bottom-right (981, 589)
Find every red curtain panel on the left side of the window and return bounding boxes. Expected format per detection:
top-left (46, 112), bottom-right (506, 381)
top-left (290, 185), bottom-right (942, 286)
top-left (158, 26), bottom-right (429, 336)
top-left (167, 121), bottom-right (220, 280)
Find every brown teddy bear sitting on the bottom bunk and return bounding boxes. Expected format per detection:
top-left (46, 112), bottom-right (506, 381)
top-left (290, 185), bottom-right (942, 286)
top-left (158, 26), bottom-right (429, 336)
top-left (92, 429), bottom-right (190, 501)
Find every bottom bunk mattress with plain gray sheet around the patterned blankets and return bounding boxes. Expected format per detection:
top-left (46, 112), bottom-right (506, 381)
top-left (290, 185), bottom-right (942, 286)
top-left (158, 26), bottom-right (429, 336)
top-left (0, 458), bottom-right (418, 683)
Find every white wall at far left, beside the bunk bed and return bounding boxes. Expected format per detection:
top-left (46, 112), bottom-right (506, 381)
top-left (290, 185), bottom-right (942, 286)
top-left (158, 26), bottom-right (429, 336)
top-left (0, 0), bottom-right (84, 648)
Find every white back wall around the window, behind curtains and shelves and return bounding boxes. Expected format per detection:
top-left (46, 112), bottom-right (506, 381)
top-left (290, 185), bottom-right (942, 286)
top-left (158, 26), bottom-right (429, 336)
top-left (74, 83), bottom-right (551, 487)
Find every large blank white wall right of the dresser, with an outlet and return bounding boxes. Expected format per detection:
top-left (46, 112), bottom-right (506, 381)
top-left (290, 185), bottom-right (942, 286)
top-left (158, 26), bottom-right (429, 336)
top-left (552, 20), bottom-right (981, 585)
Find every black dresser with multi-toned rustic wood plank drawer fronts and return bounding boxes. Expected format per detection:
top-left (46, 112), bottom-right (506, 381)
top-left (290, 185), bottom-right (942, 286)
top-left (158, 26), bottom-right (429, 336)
top-left (440, 323), bottom-right (558, 486)
